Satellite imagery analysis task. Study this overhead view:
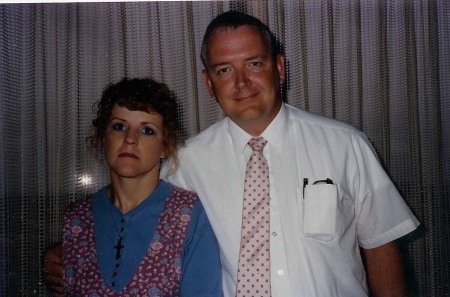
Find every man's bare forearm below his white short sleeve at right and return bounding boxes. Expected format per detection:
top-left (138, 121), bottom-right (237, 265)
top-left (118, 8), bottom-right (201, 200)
top-left (364, 241), bottom-right (405, 297)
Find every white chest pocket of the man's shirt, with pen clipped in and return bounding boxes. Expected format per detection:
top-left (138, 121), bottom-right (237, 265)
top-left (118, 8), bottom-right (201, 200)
top-left (301, 184), bottom-right (339, 241)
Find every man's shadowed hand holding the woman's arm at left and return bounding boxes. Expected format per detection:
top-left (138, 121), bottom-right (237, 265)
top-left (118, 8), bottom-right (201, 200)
top-left (42, 244), bottom-right (64, 296)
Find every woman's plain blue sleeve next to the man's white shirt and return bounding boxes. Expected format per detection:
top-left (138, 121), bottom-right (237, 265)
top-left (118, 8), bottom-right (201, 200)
top-left (180, 199), bottom-right (223, 297)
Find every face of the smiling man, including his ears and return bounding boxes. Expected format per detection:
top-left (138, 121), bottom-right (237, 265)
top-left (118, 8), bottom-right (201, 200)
top-left (202, 26), bottom-right (285, 136)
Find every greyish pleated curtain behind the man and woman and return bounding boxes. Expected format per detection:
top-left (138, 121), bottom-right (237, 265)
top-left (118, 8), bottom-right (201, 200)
top-left (0, 0), bottom-right (450, 296)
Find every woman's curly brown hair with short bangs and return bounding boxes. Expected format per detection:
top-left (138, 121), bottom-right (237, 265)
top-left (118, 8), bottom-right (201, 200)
top-left (88, 78), bottom-right (184, 171)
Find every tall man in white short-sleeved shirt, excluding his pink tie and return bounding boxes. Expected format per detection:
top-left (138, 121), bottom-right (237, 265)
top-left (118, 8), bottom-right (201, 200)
top-left (43, 12), bottom-right (418, 297)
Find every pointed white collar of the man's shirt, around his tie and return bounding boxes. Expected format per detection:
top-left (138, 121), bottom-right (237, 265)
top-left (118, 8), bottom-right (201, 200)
top-left (226, 103), bottom-right (289, 154)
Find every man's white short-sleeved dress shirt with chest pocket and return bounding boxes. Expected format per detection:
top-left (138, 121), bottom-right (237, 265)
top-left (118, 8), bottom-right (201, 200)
top-left (161, 104), bottom-right (419, 297)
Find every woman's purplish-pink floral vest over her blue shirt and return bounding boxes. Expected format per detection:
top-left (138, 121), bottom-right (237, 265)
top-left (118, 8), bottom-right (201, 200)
top-left (63, 188), bottom-right (197, 297)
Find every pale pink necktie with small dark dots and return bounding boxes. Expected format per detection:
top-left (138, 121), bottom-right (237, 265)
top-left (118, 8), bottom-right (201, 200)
top-left (236, 137), bottom-right (271, 297)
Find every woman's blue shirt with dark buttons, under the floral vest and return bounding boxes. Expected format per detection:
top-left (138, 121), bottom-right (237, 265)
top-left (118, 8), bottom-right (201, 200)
top-left (93, 180), bottom-right (222, 296)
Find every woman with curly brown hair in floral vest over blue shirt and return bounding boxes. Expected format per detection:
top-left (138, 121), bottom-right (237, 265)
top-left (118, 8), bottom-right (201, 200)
top-left (63, 79), bottom-right (222, 296)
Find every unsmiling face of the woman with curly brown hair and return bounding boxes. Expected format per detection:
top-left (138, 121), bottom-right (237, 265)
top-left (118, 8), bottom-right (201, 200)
top-left (103, 104), bottom-right (165, 179)
